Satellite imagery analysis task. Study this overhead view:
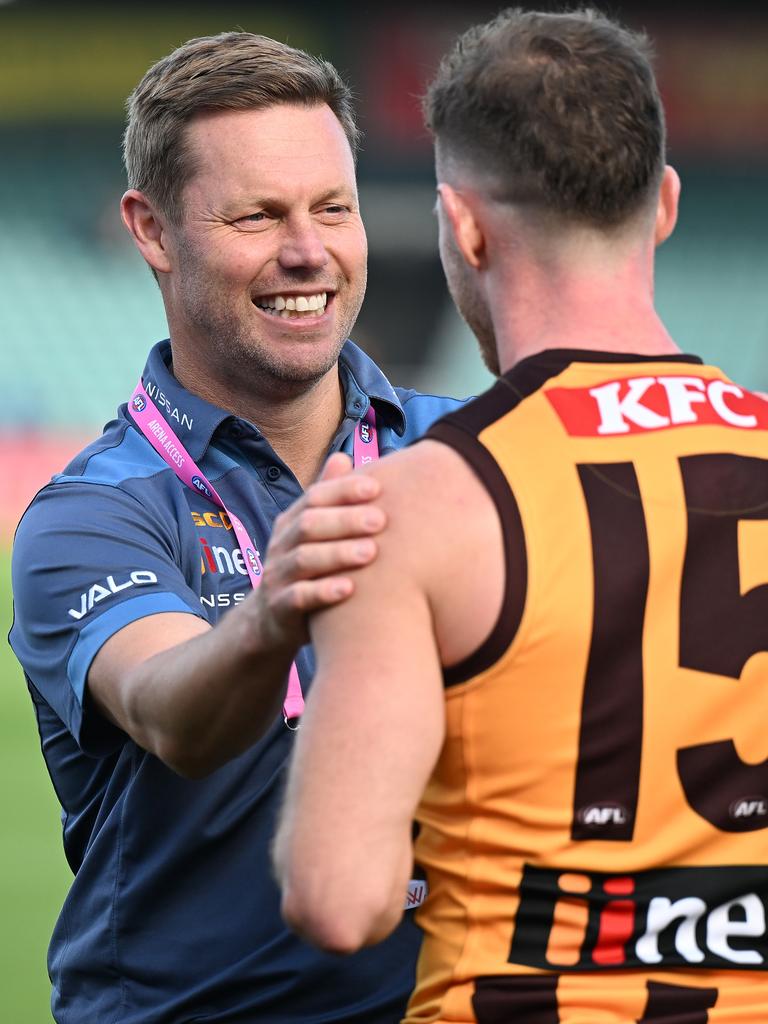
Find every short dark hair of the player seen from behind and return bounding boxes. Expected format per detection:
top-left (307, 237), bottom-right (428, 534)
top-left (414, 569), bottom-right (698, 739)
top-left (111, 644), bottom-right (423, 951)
top-left (424, 8), bottom-right (665, 227)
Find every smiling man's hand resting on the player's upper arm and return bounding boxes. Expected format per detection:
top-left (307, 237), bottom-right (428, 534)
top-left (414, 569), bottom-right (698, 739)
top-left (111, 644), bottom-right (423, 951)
top-left (254, 454), bottom-right (386, 651)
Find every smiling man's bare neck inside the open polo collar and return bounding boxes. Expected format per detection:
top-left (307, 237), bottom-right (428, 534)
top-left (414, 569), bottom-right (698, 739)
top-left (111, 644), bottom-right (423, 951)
top-left (173, 359), bottom-right (344, 487)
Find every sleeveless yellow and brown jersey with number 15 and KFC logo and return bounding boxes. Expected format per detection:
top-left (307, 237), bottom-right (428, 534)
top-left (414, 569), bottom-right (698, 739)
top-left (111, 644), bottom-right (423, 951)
top-left (406, 349), bottom-right (768, 1024)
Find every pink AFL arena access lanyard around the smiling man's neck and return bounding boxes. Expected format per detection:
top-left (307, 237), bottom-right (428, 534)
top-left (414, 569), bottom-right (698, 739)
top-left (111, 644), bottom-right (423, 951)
top-left (128, 381), bottom-right (379, 729)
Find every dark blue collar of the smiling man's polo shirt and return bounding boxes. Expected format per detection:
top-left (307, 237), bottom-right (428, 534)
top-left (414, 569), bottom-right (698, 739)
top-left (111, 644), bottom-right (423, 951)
top-left (141, 339), bottom-right (406, 462)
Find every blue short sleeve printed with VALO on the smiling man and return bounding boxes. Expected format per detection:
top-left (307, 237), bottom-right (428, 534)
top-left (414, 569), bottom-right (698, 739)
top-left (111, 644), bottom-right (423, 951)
top-left (9, 478), bottom-right (204, 756)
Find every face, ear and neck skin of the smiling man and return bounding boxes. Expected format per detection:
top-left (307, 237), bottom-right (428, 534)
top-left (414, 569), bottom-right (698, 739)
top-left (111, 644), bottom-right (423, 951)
top-left (123, 99), bottom-right (368, 484)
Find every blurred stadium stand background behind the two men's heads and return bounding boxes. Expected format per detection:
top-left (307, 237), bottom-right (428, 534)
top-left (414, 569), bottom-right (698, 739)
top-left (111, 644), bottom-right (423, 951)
top-left (0, 0), bottom-right (768, 528)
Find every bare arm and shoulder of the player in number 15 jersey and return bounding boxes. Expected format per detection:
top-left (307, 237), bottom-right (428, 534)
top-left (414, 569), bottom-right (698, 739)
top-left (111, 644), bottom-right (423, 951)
top-left (274, 441), bottom-right (503, 952)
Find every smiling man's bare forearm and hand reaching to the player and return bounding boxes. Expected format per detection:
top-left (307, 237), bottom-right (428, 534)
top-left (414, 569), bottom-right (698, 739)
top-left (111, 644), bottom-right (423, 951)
top-left (88, 455), bottom-right (385, 777)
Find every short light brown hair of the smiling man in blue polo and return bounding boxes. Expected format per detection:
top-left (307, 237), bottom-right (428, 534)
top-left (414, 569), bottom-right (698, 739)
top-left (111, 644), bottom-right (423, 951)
top-left (123, 32), bottom-right (359, 223)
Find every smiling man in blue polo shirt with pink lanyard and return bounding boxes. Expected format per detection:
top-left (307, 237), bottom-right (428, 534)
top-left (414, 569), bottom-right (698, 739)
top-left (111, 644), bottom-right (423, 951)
top-left (11, 33), bottom-right (457, 1024)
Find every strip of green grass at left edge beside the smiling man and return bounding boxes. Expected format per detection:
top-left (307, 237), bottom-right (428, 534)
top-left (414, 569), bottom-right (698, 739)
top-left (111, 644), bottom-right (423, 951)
top-left (0, 550), bottom-right (72, 1024)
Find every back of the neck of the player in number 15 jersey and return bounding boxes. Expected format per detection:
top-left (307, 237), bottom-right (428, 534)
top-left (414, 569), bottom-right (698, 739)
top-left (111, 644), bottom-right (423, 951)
top-left (492, 252), bottom-right (679, 373)
